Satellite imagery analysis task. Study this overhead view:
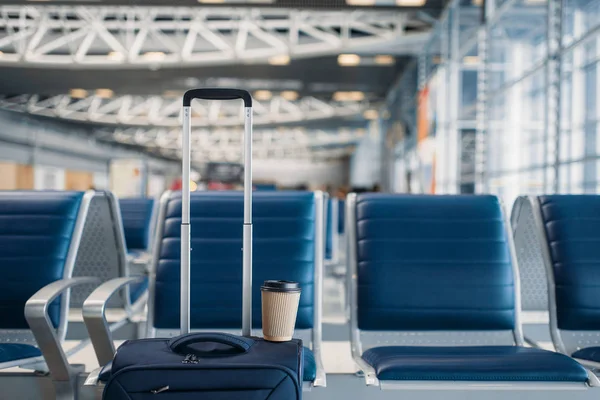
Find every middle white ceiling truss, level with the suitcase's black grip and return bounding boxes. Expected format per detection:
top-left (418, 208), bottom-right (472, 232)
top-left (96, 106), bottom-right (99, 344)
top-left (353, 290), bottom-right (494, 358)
top-left (0, 95), bottom-right (369, 127)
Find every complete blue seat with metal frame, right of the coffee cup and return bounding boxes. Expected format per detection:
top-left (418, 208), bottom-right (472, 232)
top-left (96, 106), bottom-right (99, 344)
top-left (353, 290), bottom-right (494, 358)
top-left (347, 194), bottom-right (599, 388)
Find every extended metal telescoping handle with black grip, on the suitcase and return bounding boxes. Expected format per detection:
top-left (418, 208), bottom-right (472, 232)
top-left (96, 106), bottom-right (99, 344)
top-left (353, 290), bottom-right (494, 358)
top-left (180, 89), bottom-right (252, 337)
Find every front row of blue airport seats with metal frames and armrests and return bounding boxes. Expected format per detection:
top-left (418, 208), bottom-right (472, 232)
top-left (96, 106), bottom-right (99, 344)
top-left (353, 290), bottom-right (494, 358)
top-left (0, 192), bottom-right (600, 396)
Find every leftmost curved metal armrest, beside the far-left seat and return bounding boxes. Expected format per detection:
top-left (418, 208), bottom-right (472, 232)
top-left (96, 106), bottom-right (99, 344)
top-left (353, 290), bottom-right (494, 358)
top-left (25, 277), bottom-right (98, 381)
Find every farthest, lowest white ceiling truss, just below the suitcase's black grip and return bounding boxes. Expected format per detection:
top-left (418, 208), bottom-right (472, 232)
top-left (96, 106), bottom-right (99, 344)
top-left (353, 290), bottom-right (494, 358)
top-left (96, 128), bottom-right (364, 163)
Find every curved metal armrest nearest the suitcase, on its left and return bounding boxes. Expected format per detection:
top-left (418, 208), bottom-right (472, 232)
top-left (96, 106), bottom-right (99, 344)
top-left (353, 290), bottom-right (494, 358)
top-left (82, 276), bottom-right (144, 366)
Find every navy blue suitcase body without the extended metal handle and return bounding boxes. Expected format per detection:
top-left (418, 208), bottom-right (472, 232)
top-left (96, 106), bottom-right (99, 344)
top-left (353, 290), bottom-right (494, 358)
top-left (103, 333), bottom-right (303, 400)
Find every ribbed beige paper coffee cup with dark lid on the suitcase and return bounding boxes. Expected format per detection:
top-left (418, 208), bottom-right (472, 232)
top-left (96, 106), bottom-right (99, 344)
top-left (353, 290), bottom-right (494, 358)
top-left (260, 281), bottom-right (301, 342)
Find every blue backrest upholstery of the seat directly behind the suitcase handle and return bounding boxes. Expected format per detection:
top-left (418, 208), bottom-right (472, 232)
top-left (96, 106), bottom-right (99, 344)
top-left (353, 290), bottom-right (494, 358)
top-left (154, 191), bottom-right (315, 329)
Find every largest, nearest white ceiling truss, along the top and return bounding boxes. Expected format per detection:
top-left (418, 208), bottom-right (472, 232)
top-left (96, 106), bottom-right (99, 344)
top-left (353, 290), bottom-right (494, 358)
top-left (0, 5), bottom-right (410, 68)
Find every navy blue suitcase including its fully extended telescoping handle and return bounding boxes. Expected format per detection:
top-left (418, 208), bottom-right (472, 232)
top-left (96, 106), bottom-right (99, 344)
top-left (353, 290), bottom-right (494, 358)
top-left (102, 89), bottom-right (304, 400)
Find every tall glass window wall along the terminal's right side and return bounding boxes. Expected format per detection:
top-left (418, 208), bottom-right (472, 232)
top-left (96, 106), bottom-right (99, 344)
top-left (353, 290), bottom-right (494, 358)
top-left (384, 0), bottom-right (600, 200)
